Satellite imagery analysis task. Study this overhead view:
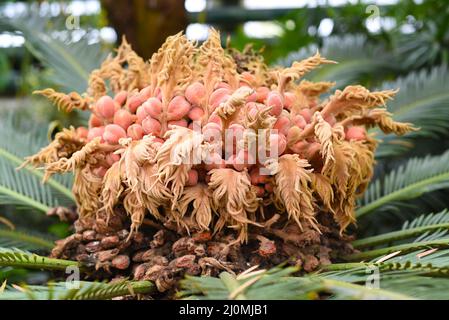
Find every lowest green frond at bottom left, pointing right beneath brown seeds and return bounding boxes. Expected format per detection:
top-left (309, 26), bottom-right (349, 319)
top-left (0, 280), bottom-right (154, 300)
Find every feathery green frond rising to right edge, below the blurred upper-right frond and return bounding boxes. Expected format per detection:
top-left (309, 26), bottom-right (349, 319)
top-left (356, 151), bottom-right (449, 217)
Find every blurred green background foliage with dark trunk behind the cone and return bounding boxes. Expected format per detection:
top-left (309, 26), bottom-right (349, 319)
top-left (0, 0), bottom-right (449, 282)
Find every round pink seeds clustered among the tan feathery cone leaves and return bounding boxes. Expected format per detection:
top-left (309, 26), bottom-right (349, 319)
top-left (77, 73), bottom-right (366, 191)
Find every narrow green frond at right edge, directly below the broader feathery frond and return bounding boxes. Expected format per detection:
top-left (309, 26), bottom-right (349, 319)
top-left (352, 209), bottom-right (449, 249)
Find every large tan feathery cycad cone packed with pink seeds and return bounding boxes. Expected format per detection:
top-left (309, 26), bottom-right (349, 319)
top-left (26, 30), bottom-right (414, 287)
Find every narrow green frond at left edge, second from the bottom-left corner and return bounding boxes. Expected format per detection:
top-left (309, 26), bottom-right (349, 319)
top-left (0, 248), bottom-right (82, 270)
